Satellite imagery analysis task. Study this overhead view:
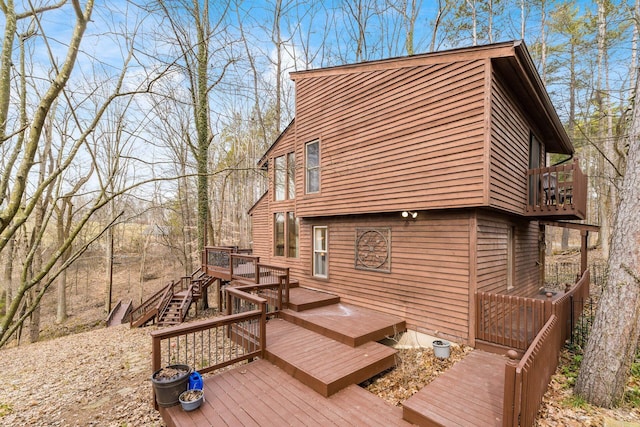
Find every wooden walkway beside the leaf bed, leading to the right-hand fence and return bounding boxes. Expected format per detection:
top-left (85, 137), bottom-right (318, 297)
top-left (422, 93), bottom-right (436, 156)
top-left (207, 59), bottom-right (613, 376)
top-left (403, 350), bottom-right (506, 427)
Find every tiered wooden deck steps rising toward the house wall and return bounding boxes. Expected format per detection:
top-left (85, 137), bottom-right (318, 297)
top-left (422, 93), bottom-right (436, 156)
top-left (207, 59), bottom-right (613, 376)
top-left (266, 287), bottom-right (406, 397)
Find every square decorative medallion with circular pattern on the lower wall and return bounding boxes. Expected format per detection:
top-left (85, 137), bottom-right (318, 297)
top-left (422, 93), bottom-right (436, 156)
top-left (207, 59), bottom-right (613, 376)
top-left (355, 228), bottom-right (391, 273)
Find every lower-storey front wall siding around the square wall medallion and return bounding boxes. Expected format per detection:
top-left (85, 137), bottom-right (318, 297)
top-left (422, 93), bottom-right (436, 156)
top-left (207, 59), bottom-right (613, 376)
top-left (291, 212), bottom-right (470, 341)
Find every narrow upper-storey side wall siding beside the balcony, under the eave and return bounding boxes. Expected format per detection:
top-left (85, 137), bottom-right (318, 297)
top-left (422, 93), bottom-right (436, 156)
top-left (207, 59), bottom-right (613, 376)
top-left (489, 74), bottom-right (530, 214)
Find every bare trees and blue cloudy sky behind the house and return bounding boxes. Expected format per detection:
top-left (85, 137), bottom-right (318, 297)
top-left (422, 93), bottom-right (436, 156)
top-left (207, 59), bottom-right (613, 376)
top-left (0, 0), bottom-right (640, 346)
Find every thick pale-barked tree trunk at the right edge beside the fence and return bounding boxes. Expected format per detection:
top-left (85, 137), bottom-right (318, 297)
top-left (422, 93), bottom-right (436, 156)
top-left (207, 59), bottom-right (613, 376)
top-left (575, 70), bottom-right (640, 407)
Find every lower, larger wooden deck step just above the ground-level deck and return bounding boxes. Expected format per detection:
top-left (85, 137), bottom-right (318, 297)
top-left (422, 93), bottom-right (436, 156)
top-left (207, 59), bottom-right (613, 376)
top-left (266, 319), bottom-right (396, 397)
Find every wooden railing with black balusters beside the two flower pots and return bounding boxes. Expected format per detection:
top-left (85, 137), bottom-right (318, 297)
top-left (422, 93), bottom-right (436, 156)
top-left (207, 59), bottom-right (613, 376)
top-left (151, 289), bottom-right (267, 404)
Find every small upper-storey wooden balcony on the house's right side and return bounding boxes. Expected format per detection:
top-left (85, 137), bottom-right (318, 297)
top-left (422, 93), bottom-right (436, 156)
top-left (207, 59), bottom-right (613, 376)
top-left (525, 160), bottom-right (587, 219)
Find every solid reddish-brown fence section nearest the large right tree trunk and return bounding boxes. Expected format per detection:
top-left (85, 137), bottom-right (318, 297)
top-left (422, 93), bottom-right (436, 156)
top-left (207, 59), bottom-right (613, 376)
top-left (502, 314), bottom-right (563, 427)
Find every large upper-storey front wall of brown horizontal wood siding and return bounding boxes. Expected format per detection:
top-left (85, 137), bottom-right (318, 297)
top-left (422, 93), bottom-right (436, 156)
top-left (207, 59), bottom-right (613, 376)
top-left (295, 61), bottom-right (485, 217)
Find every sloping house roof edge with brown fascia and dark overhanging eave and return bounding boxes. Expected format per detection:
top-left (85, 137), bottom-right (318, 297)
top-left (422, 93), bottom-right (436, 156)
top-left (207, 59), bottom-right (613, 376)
top-left (288, 41), bottom-right (574, 155)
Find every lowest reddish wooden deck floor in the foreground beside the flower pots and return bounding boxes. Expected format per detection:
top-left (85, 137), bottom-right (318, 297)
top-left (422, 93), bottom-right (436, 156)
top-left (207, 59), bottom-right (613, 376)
top-left (160, 360), bottom-right (410, 427)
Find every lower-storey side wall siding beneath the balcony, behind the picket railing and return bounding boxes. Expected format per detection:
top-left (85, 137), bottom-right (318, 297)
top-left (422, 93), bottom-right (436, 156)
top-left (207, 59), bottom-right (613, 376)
top-left (476, 213), bottom-right (540, 297)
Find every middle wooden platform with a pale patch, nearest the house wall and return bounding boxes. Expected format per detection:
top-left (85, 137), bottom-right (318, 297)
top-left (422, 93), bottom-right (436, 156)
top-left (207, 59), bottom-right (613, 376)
top-left (280, 303), bottom-right (407, 347)
